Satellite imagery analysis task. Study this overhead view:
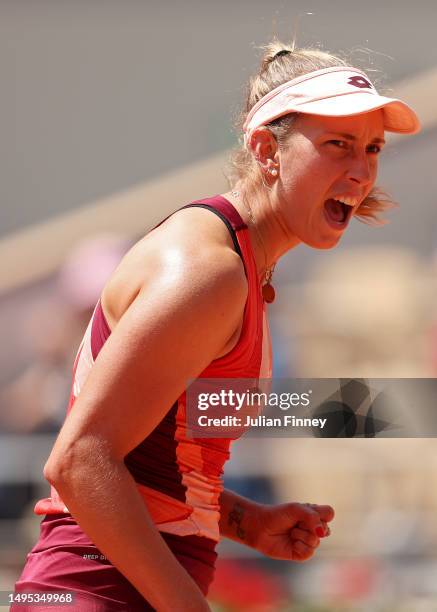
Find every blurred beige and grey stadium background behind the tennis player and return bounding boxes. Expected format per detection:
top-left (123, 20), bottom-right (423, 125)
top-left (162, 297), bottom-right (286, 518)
top-left (0, 0), bottom-right (437, 612)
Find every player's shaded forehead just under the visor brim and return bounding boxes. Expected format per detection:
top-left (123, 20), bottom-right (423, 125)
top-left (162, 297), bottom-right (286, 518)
top-left (294, 109), bottom-right (384, 139)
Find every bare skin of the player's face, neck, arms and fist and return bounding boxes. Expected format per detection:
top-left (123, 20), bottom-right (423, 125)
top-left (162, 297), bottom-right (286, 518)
top-left (44, 106), bottom-right (383, 611)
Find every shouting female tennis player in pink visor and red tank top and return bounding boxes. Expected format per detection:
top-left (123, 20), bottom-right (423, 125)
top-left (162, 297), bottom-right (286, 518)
top-left (12, 41), bottom-right (419, 612)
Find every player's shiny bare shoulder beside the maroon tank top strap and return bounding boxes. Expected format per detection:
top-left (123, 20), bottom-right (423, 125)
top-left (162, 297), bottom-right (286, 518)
top-left (102, 207), bottom-right (247, 328)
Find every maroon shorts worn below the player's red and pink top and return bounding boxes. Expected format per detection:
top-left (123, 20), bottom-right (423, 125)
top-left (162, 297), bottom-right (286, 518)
top-left (10, 514), bottom-right (217, 612)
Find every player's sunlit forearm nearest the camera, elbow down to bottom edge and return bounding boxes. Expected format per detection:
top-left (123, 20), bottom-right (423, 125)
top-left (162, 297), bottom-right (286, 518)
top-left (48, 457), bottom-right (209, 612)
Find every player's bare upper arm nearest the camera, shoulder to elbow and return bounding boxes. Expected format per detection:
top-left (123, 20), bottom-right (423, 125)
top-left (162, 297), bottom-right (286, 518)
top-left (45, 237), bottom-right (247, 479)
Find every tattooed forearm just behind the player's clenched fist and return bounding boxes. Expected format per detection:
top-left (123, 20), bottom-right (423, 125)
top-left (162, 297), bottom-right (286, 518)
top-left (219, 489), bottom-right (262, 548)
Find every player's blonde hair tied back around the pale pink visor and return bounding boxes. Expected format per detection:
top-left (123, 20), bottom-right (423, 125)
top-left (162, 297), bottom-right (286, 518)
top-left (226, 39), bottom-right (397, 225)
